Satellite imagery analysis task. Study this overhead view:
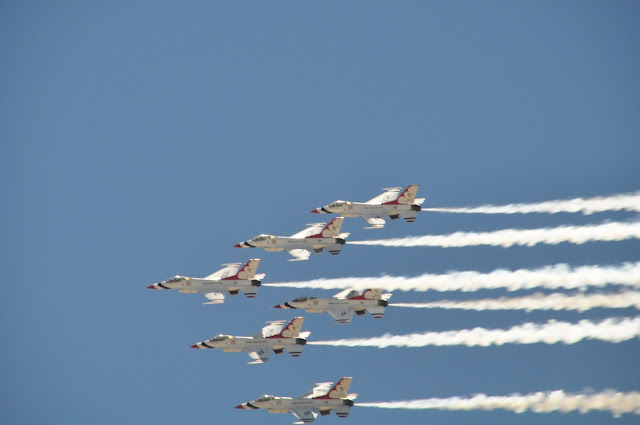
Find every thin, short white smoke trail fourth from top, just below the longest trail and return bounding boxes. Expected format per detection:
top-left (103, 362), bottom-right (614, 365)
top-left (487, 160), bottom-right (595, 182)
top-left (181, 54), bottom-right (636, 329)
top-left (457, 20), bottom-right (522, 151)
top-left (389, 291), bottom-right (640, 311)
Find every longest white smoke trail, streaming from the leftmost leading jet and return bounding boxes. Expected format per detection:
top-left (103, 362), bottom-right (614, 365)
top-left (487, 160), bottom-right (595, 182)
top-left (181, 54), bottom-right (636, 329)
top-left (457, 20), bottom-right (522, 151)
top-left (263, 262), bottom-right (640, 292)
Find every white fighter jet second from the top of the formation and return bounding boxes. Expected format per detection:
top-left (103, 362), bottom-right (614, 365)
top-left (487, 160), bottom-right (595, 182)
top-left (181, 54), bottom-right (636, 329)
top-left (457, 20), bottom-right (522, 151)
top-left (234, 217), bottom-right (349, 261)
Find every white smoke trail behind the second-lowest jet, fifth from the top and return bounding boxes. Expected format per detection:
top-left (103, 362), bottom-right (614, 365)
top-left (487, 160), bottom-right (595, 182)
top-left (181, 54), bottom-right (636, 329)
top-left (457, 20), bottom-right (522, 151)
top-left (307, 316), bottom-right (640, 348)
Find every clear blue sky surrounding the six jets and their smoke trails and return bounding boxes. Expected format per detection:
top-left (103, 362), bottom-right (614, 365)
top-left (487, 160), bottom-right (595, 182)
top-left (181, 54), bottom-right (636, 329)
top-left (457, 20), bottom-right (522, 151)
top-left (0, 1), bottom-right (640, 425)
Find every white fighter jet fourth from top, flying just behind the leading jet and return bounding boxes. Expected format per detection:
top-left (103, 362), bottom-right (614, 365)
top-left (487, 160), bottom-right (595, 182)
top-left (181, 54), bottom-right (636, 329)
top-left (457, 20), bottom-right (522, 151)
top-left (273, 288), bottom-right (392, 325)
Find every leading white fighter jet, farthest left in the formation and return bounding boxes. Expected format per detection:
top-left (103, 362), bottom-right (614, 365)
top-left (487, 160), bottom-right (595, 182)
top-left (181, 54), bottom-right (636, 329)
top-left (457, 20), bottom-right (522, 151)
top-left (147, 258), bottom-right (266, 304)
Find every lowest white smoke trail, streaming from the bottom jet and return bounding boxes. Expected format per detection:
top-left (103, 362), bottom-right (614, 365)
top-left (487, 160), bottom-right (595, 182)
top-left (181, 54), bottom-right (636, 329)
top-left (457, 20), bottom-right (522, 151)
top-left (355, 390), bottom-right (640, 417)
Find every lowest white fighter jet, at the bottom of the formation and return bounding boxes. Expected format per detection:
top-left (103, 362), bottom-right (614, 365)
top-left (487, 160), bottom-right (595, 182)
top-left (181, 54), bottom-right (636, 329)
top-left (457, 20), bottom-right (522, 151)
top-left (236, 377), bottom-right (358, 424)
